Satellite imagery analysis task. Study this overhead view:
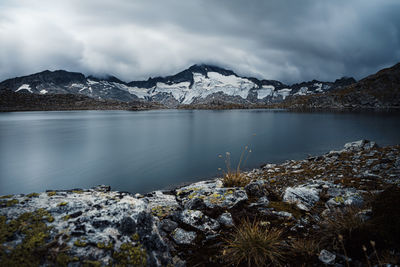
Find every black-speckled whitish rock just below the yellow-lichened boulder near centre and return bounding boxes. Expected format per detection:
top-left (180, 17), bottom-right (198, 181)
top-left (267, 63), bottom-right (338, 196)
top-left (181, 210), bottom-right (219, 232)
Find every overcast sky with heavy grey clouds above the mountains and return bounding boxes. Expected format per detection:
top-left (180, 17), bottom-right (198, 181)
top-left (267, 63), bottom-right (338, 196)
top-left (0, 0), bottom-right (400, 84)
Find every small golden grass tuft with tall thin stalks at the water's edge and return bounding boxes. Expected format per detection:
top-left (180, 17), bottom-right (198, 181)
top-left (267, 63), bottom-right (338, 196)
top-left (219, 146), bottom-right (251, 187)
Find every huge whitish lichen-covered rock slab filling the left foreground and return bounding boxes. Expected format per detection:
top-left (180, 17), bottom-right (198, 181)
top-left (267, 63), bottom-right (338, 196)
top-left (0, 187), bottom-right (171, 266)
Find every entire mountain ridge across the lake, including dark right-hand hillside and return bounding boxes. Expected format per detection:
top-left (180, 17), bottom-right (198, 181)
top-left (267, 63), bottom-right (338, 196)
top-left (0, 64), bottom-right (400, 108)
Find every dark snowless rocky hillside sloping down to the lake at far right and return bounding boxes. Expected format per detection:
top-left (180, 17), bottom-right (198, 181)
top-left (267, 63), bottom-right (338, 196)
top-left (282, 63), bottom-right (400, 109)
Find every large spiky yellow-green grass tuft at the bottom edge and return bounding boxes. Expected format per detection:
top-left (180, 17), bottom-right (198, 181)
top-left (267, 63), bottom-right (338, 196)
top-left (222, 220), bottom-right (285, 266)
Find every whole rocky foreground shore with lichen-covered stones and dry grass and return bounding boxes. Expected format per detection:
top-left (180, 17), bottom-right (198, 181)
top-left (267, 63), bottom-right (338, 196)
top-left (0, 140), bottom-right (400, 266)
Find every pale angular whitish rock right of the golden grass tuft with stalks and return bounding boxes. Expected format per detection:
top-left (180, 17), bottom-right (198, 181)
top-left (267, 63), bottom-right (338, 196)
top-left (283, 185), bottom-right (319, 211)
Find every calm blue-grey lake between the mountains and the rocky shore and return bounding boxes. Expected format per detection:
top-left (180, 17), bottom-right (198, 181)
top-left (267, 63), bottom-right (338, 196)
top-left (0, 110), bottom-right (400, 195)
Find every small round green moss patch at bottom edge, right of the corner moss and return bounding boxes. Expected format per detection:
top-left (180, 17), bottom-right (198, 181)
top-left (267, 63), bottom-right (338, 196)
top-left (113, 243), bottom-right (147, 266)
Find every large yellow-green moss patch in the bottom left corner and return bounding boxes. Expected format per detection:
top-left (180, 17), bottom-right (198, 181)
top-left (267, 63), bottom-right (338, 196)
top-left (0, 209), bottom-right (51, 266)
